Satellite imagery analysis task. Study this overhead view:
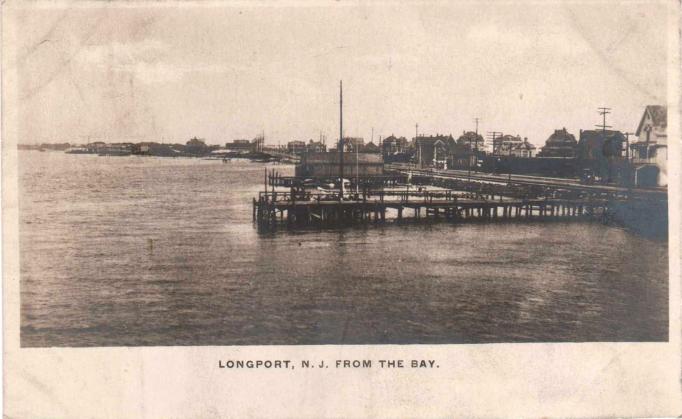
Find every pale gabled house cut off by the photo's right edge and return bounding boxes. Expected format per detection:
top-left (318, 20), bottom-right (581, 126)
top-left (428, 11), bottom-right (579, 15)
top-left (630, 105), bottom-right (668, 186)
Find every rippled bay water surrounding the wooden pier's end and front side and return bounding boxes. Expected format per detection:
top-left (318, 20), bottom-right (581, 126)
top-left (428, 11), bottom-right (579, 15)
top-left (19, 151), bottom-right (668, 346)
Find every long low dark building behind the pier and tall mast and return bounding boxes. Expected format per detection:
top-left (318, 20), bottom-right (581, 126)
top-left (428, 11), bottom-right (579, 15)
top-left (296, 151), bottom-right (384, 178)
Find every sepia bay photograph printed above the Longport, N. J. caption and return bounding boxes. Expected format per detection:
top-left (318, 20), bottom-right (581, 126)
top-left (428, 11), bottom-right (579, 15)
top-left (10, 2), bottom-right (670, 348)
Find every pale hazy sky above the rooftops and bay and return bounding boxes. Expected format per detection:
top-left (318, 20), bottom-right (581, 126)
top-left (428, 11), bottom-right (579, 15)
top-left (5, 2), bottom-right (668, 145)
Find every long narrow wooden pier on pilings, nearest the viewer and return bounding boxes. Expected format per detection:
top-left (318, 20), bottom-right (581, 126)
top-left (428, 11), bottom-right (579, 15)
top-left (253, 188), bottom-right (609, 229)
